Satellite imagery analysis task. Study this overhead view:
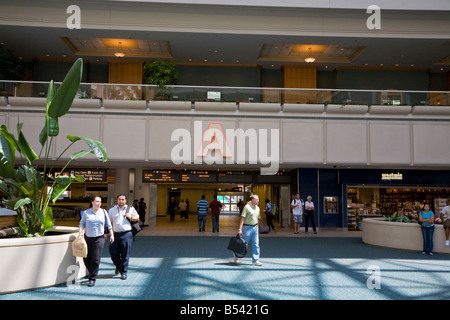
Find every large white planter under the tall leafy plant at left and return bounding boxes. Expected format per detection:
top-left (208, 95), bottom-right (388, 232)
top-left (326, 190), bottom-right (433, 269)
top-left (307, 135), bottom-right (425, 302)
top-left (0, 227), bottom-right (87, 294)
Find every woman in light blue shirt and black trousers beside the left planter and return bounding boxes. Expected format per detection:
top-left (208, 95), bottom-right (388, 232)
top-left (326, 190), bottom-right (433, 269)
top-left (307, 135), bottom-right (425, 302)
top-left (79, 196), bottom-right (114, 287)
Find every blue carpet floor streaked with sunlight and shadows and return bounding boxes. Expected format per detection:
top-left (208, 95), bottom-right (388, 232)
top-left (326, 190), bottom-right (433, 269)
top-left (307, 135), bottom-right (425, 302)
top-left (0, 236), bottom-right (450, 300)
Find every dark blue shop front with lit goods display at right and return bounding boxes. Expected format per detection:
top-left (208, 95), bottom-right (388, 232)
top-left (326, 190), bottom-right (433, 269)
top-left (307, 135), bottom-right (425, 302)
top-left (298, 168), bottom-right (450, 230)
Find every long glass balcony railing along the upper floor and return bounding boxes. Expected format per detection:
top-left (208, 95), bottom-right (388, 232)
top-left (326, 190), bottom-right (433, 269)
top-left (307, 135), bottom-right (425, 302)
top-left (0, 80), bottom-right (450, 106)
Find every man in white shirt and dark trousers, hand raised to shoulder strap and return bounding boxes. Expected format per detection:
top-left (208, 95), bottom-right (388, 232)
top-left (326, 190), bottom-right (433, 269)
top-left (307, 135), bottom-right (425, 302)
top-left (108, 194), bottom-right (139, 280)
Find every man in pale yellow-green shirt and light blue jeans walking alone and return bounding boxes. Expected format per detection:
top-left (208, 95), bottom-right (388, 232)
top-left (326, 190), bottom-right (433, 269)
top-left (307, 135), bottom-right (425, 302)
top-left (234, 194), bottom-right (262, 266)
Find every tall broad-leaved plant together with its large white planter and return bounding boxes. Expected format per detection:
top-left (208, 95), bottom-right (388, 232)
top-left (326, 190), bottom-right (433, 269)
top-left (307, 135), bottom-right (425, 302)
top-left (0, 59), bottom-right (108, 294)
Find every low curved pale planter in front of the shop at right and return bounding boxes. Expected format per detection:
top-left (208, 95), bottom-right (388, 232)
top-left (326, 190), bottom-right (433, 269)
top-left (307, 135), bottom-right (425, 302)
top-left (362, 218), bottom-right (450, 253)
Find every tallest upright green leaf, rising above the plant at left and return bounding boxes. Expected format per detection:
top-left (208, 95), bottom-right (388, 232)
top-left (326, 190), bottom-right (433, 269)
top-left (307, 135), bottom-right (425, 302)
top-left (48, 58), bottom-right (83, 119)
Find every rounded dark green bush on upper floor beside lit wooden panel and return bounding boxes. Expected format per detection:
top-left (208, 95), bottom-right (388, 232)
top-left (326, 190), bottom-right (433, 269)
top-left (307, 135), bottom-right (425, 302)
top-left (142, 60), bottom-right (178, 88)
